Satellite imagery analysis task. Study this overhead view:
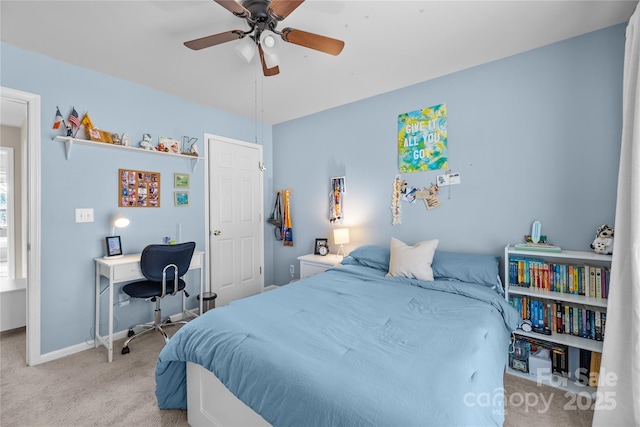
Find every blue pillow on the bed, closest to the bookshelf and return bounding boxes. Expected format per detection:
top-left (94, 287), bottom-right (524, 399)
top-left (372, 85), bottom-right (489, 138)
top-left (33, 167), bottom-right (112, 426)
top-left (431, 251), bottom-right (504, 294)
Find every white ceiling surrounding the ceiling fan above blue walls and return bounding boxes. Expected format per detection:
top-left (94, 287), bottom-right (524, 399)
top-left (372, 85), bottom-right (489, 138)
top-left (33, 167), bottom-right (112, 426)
top-left (0, 0), bottom-right (638, 124)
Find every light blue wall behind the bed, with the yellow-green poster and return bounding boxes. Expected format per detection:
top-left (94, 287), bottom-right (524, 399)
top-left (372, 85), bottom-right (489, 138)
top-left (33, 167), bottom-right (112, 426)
top-left (273, 25), bottom-right (626, 284)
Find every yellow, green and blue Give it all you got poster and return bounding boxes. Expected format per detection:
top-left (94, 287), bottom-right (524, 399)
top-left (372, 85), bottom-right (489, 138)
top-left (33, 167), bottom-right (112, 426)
top-left (398, 104), bottom-right (449, 173)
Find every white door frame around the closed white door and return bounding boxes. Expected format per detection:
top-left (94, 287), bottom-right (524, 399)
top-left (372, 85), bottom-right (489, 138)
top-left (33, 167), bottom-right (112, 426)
top-left (204, 133), bottom-right (265, 302)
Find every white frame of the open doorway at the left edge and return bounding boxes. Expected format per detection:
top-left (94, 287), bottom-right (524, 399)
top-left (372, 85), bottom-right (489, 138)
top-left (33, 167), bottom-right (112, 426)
top-left (0, 86), bottom-right (42, 366)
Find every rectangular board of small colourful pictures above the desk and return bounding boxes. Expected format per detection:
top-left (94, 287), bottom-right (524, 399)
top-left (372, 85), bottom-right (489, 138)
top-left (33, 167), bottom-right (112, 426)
top-left (118, 169), bottom-right (160, 208)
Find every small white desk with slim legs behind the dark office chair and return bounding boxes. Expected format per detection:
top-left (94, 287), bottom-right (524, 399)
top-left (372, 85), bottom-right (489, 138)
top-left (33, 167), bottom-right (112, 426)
top-left (94, 251), bottom-right (204, 362)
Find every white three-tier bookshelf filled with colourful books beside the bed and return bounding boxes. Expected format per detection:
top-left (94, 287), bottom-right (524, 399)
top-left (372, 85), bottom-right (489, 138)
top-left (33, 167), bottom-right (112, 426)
top-left (504, 245), bottom-right (611, 396)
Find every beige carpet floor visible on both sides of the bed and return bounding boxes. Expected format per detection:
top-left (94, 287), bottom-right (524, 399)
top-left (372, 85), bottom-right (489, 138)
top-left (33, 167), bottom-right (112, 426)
top-left (0, 328), bottom-right (593, 427)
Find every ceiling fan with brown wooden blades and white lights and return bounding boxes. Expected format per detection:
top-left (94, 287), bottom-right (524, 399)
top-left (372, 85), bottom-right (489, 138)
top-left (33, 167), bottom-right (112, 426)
top-left (184, 0), bottom-right (344, 76)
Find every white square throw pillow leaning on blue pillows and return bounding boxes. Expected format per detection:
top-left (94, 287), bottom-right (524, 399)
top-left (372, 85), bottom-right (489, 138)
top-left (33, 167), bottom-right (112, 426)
top-left (387, 237), bottom-right (439, 282)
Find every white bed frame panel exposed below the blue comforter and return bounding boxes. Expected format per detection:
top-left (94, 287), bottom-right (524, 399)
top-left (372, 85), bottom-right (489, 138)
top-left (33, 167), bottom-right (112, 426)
top-left (187, 362), bottom-right (271, 427)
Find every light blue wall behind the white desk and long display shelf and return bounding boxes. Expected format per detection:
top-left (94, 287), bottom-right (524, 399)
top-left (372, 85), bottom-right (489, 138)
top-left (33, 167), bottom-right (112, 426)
top-left (0, 43), bottom-right (273, 354)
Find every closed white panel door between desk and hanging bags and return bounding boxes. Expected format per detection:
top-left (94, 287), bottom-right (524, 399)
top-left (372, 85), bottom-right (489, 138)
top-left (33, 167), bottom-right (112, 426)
top-left (208, 137), bottom-right (264, 305)
